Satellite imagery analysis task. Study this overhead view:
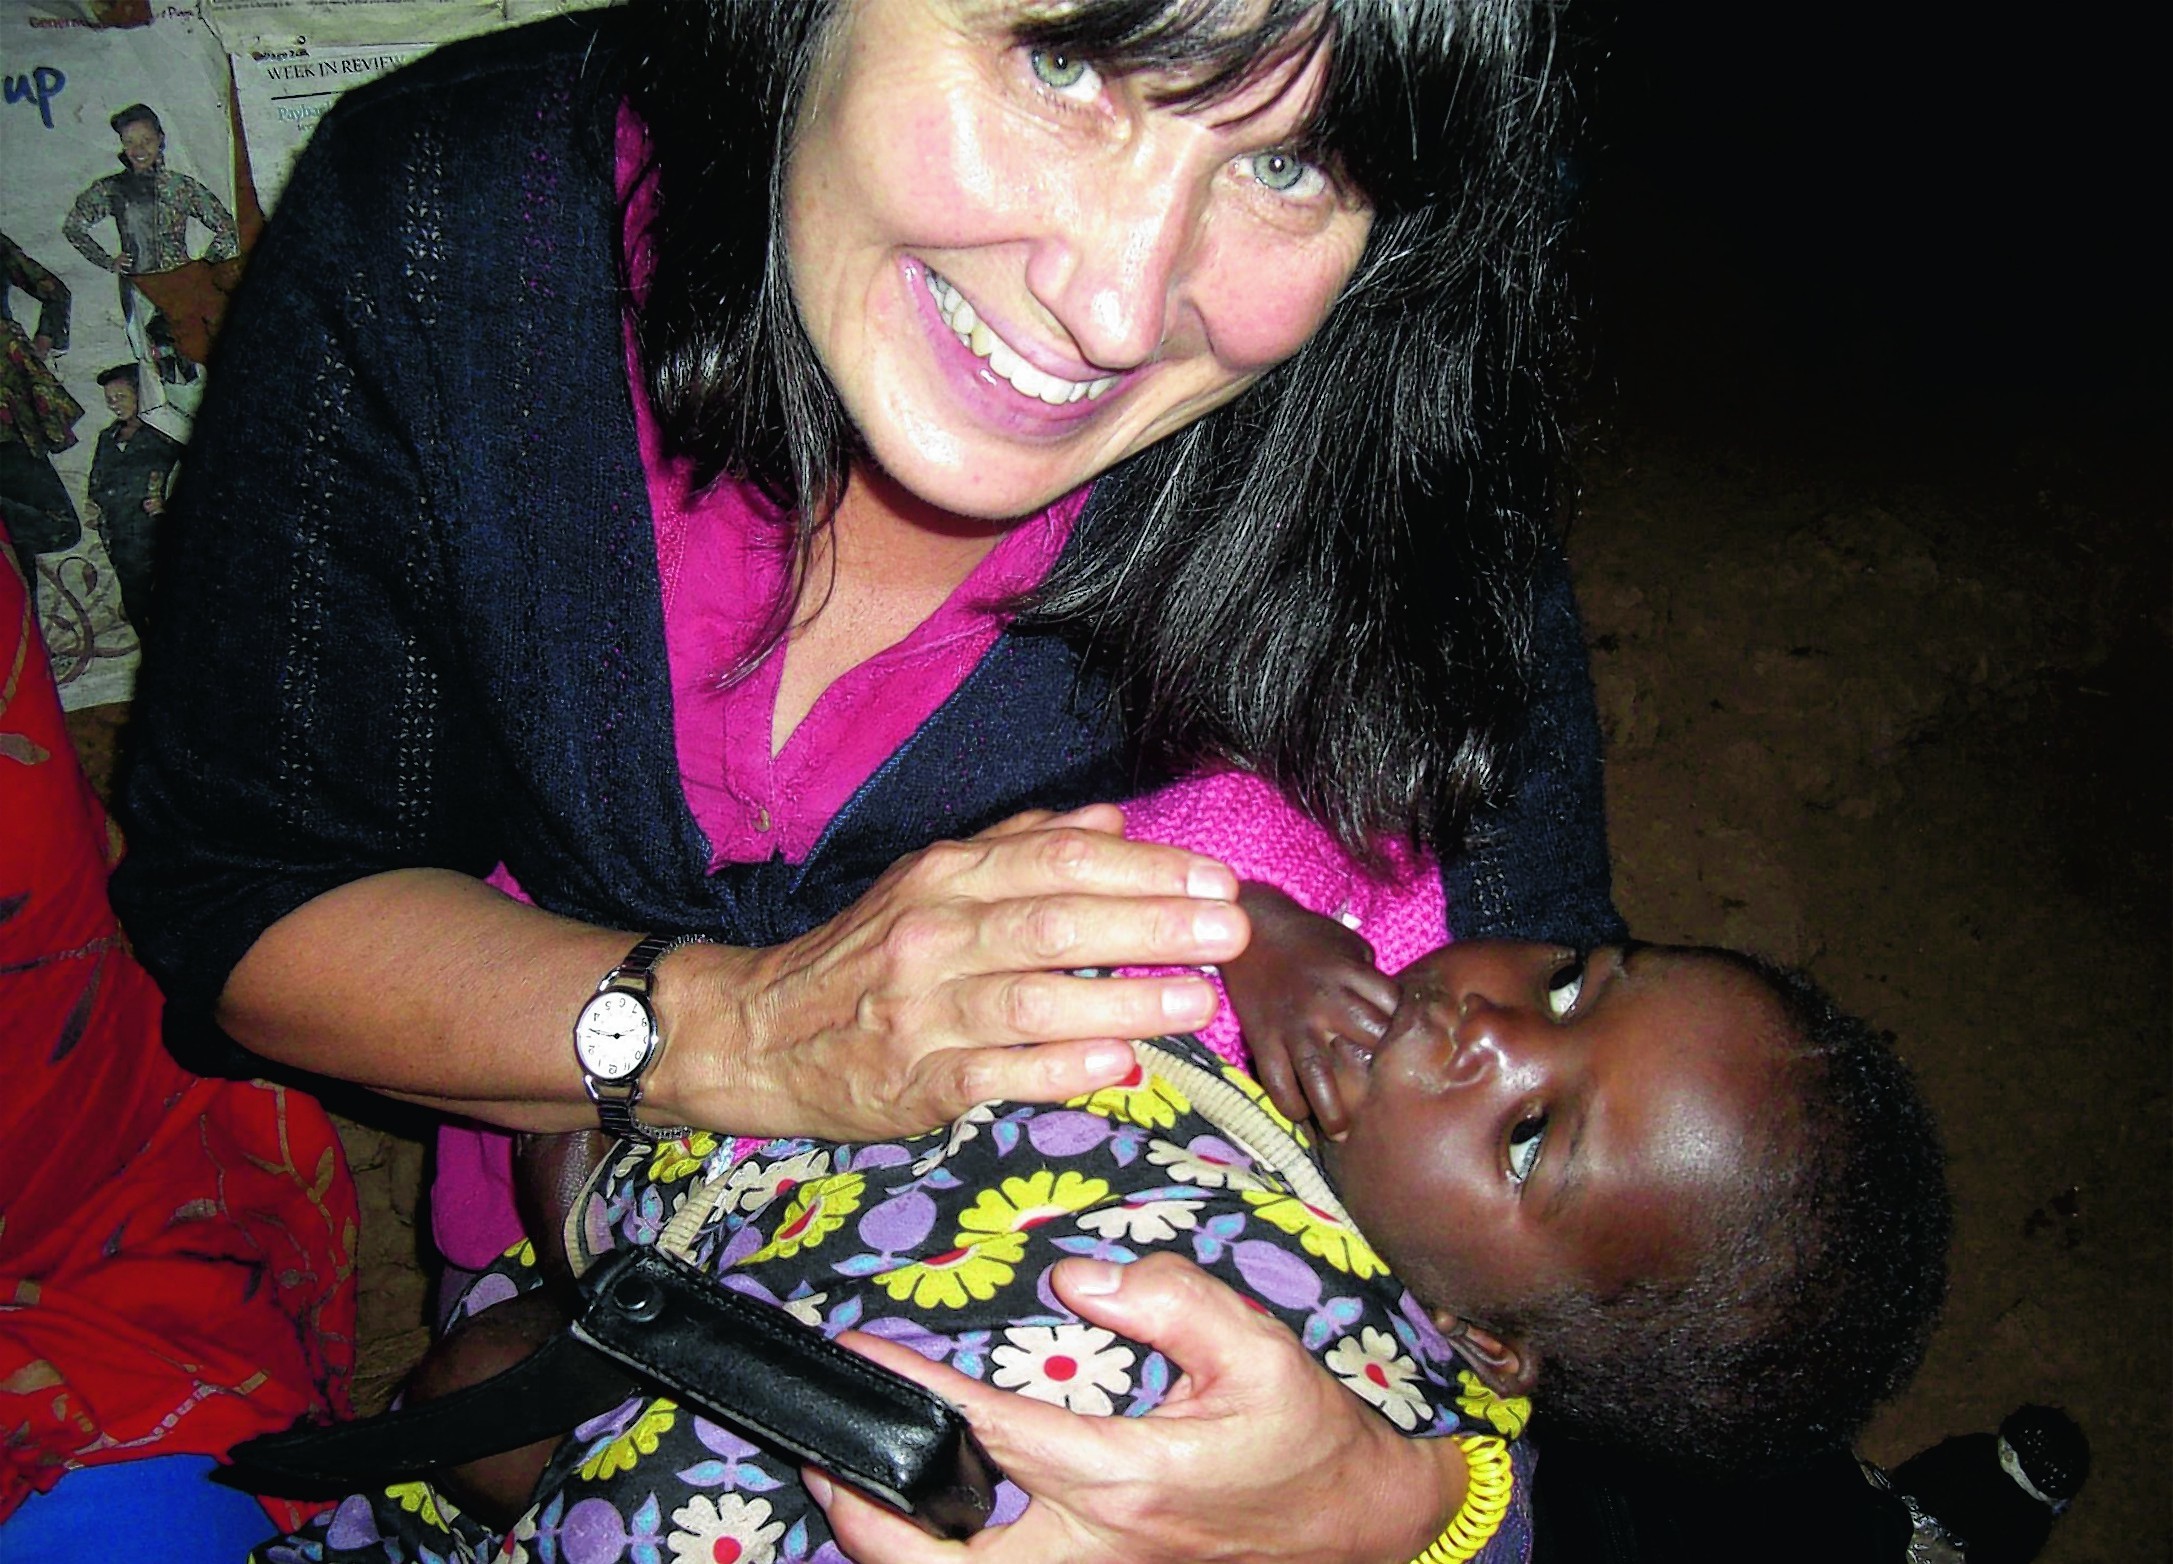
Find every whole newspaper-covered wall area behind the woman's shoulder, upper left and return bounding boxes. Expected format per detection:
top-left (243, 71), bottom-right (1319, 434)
top-left (0, 0), bottom-right (612, 710)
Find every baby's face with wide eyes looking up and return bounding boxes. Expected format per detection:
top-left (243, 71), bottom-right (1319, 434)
top-left (1326, 941), bottom-right (1784, 1323)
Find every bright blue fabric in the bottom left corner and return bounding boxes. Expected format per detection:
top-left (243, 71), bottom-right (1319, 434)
top-left (0, 1455), bottom-right (278, 1564)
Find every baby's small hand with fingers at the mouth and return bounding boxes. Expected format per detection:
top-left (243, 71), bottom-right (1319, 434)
top-left (1221, 880), bottom-right (1399, 1140)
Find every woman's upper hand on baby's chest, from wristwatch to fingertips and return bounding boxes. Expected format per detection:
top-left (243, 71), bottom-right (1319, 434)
top-left (643, 804), bottom-right (1247, 1140)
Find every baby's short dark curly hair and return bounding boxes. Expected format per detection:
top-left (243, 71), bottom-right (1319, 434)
top-left (1497, 951), bottom-right (1954, 1475)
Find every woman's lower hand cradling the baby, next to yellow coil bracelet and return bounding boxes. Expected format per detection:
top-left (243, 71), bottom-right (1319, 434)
top-left (806, 1253), bottom-right (1465, 1564)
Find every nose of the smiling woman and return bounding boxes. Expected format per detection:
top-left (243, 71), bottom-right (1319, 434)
top-left (1026, 154), bottom-right (1204, 371)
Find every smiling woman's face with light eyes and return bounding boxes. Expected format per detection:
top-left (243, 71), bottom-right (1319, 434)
top-left (787, 0), bottom-right (1371, 519)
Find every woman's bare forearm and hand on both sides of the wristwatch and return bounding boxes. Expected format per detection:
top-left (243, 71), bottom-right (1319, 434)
top-left (217, 808), bottom-right (1245, 1140)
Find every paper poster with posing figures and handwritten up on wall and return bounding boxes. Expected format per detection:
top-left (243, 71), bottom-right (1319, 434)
top-left (0, 0), bottom-right (241, 708)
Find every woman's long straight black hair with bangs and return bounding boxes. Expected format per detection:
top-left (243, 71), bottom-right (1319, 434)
top-left (632, 0), bottom-right (1565, 852)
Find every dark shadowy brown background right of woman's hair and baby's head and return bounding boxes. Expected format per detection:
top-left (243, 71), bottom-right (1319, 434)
top-left (1569, 4), bottom-right (2173, 1564)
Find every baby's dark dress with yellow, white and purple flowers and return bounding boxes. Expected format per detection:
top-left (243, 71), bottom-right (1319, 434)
top-left (256, 1038), bottom-right (1530, 1564)
